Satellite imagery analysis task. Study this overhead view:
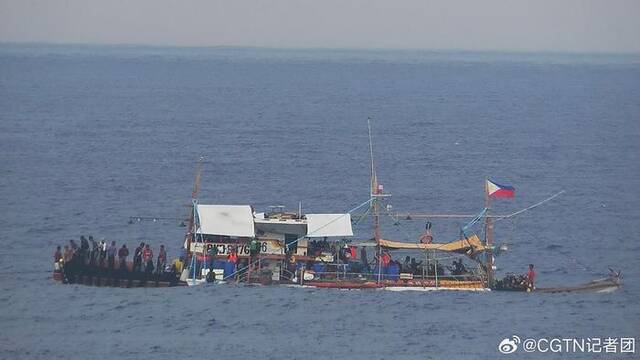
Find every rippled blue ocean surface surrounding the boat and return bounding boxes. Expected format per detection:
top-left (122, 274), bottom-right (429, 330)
top-left (0, 44), bottom-right (640, 360)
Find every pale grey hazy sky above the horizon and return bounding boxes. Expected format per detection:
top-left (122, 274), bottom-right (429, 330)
top-left (0, 0), bottom-right (640, 52)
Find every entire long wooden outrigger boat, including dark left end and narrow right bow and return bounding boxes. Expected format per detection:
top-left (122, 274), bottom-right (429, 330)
top-left (54, 123), bottom-right (619, 292)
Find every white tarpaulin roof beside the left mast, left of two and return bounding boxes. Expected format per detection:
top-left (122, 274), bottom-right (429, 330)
top-left (198, 205), bottom-right (255, 237)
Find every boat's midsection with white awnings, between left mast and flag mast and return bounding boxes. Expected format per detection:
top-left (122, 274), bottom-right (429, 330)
top-left (181, 122), bottom-right (492, 291)
